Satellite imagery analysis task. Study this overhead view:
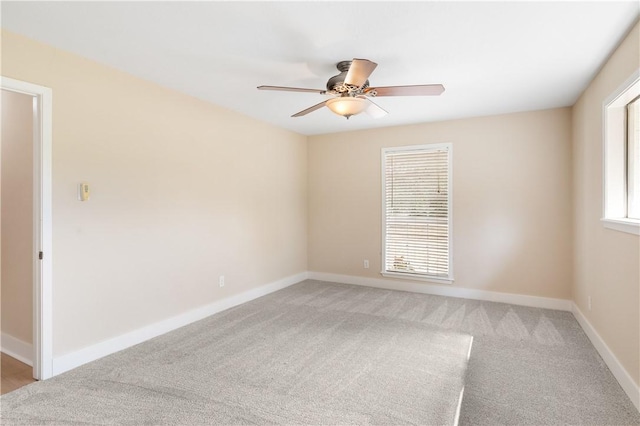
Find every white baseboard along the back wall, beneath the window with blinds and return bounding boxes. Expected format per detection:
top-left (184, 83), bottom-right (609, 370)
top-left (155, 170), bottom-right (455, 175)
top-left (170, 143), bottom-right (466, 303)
top-left (309, 272), bottom-right (572, 312)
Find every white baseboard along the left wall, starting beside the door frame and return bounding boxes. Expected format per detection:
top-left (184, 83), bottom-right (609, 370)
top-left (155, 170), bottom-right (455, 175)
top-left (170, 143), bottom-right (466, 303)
top-left (53, 272), bottom-right (307, 376)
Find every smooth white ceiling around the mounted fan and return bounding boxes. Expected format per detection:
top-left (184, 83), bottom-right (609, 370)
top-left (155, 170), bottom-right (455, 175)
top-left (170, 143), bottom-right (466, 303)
top-left (0, 1), bottom-right (640, 135)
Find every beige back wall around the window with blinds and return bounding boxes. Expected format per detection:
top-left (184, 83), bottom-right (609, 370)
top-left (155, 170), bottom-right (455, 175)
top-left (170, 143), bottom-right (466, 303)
top-left (309, 108), bottom-right (572, 299)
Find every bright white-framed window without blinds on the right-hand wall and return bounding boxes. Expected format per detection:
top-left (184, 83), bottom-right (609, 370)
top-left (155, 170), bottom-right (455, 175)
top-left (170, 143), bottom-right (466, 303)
top-left (602, 70), bottom-right (640, 235)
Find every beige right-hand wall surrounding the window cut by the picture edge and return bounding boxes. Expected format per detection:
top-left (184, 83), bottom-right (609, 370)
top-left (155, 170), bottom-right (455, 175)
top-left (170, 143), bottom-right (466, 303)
top-left (573, 20), bottom-right (640, 384)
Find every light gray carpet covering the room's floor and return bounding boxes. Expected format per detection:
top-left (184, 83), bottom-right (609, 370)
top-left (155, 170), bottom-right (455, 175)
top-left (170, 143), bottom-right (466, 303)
top-left (0, 281), bottom-right (640, 425)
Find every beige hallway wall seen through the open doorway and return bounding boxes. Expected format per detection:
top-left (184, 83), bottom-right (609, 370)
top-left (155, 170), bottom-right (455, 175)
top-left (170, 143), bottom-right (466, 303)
top-left (0, 90), bottom-right (33, 343)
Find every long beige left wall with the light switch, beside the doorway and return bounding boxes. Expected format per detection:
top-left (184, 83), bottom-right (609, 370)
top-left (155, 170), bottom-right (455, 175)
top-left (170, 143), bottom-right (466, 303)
top-left (2, 32), bottom-right (307, 356)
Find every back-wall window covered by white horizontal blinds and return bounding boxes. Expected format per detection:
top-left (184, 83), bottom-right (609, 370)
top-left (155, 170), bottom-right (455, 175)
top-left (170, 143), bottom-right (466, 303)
top-left (382, 144), bottom-right (453, 283)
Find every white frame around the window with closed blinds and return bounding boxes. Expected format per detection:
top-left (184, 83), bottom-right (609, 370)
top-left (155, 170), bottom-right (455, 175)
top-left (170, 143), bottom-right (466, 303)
top-left (380, 143), bottom-right (454, 284)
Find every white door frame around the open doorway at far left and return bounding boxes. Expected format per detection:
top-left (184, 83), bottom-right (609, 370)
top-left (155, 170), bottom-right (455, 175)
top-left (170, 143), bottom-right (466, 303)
top-left (0, 77), bottom-right (53, 380)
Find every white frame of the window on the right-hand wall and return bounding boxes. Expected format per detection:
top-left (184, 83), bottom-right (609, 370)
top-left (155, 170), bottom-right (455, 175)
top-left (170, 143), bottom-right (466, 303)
top-left (600, 69), bottom-right (640, 235)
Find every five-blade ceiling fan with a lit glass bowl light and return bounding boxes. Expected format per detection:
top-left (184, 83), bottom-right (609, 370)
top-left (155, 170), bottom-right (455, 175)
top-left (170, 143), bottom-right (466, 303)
top-left (258, 58), bottom-right (444, 119)
